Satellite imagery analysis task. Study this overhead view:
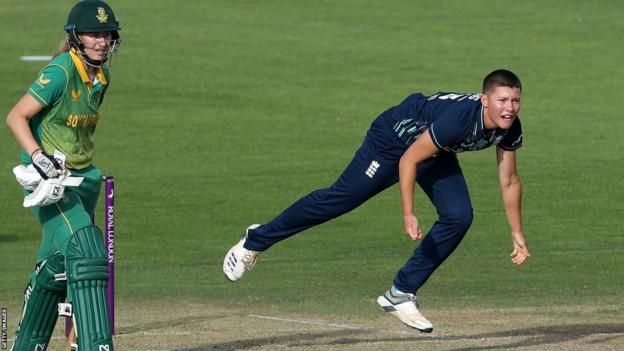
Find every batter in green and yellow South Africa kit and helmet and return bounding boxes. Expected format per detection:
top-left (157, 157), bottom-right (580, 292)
top-left (7, 0), bottom-right (120, 351)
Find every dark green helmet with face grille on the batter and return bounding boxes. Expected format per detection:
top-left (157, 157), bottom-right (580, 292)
top-left (65, 0), bottom-right (121, 67)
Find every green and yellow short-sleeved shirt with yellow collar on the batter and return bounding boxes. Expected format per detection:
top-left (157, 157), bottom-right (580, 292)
top-left (22, 49), bottom-right (109, 170)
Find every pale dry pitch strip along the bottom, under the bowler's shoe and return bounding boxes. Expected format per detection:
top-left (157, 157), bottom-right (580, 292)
top-left (35, 301), bottom-right (624, 351)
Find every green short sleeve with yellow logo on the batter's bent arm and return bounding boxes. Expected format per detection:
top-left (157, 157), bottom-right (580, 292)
top-left (28, 65), bottom-right (68, 108)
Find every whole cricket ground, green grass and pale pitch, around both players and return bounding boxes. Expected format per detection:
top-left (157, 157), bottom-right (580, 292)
top-left (0, 0), bottom-right (624, 350)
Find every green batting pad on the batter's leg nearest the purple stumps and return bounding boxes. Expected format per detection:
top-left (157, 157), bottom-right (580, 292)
top-left (65, 226), bottom-right (113, 351)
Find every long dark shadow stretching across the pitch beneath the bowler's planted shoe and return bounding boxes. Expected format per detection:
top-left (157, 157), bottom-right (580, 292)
top-left (176, 323), bottom-right (624, 351)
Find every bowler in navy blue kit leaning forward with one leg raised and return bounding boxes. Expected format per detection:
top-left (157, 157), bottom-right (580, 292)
top-left (223, 69), bottom-right (529, 332)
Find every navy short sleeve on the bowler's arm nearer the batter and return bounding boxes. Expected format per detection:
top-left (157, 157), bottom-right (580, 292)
top-left (429, 108), bottom-right (470, 149)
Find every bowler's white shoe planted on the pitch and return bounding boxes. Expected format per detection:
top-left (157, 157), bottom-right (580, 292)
top-left (377, 286), bottom-right (433, 333)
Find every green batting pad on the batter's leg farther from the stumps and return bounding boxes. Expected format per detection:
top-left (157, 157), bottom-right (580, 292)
top-left (11, 252), bottom-right (67, 351)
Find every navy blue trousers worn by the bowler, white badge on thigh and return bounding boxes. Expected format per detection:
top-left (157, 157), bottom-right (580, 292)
top-left (245, 117), bottom-right (472, 293)
